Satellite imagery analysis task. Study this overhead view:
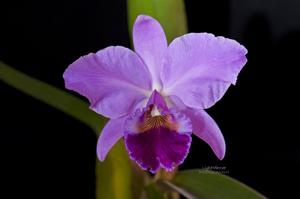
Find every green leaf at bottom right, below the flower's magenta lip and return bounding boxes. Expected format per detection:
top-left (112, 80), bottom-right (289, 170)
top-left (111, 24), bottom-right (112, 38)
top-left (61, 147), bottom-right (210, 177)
top-left (165, 169), bottom-right (266, 199)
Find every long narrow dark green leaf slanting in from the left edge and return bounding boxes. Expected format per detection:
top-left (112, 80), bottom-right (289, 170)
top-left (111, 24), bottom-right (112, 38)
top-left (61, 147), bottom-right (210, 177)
top-left (0, 61), bottom-right (106, 133)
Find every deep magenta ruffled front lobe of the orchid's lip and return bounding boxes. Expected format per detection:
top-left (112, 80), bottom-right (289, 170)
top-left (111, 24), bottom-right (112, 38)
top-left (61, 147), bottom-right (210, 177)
top-left (125, 128), bottom-right (191, 173)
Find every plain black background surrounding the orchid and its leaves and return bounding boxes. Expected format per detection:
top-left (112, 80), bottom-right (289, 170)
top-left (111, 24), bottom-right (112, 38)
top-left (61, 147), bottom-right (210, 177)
top-left (0, 0), bottom-right (300, 199)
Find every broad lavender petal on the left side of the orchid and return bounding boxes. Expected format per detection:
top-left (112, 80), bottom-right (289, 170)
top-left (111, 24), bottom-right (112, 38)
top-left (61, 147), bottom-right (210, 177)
top-left (64, 46), bottom-right (151, 118)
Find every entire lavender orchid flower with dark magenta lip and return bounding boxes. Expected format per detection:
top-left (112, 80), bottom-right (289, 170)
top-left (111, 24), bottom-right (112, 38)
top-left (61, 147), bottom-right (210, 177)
top-left (63, 15), bottom-right (247, 173)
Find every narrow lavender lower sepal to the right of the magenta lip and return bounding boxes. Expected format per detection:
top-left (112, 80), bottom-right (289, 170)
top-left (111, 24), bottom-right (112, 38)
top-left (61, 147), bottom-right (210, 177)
top-left (183, 108), bottom-right (226, 160)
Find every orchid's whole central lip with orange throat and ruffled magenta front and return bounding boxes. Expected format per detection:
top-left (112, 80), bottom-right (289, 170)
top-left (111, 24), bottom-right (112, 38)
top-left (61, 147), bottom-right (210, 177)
top-left (124, 91), bottom-right (192, 173)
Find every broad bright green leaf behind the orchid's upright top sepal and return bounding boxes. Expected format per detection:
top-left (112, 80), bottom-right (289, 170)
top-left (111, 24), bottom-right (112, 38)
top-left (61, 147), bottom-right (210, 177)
top-left (127, 0), bottom-right (187, 42)
